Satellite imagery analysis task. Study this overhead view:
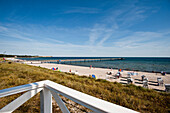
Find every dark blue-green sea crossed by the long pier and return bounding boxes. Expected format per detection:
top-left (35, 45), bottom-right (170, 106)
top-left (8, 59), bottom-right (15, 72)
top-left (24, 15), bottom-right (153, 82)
top-left (19, 57), bottom-right (170, 73)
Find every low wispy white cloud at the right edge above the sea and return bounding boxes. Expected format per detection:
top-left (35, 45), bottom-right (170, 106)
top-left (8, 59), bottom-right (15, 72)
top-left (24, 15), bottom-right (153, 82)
top-left (113, 32), bottom-right (170, 49)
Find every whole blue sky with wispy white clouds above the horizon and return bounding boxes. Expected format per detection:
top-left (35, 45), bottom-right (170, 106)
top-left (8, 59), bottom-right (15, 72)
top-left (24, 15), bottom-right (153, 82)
top-left (0, 0), bottom-right (170, 57)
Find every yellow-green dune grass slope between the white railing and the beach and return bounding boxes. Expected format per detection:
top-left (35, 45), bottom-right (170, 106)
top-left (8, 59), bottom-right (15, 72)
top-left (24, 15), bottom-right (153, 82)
top-left (0, 63), bottom-right (170, 113)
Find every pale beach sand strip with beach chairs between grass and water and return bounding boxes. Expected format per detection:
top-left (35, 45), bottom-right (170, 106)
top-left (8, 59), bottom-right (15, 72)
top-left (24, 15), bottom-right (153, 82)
top-left (24, 61), bottom-right (170, 91)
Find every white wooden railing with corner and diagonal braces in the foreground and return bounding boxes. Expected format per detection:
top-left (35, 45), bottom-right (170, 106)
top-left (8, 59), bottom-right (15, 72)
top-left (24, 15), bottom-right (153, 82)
top-left (0, 80), bottom-right (136, 113)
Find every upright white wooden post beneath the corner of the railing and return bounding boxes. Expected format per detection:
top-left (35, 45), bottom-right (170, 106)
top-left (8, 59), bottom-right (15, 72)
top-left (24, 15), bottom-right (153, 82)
top-left (40, 87), bottom-right (52, 113)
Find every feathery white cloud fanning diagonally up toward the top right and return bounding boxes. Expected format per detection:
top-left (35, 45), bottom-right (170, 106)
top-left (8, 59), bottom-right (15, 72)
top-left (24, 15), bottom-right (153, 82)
top-left (89, 1), bottom-right (160, 46)
